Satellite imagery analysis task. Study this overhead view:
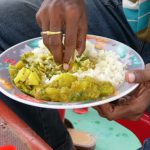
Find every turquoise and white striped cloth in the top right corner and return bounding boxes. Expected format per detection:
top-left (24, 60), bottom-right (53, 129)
top-left (123, 0), bottom-right (150, 42)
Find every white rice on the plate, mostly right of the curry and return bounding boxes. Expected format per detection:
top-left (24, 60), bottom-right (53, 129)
top-left (33, 42), bottom-right (126, 88)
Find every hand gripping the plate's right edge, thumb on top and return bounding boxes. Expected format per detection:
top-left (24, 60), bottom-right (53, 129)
top-left (95, 64), bottom-right (150, 120)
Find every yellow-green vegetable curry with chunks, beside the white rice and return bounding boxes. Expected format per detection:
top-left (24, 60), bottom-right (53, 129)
top-left (9, 49), bottom-right (115, 102)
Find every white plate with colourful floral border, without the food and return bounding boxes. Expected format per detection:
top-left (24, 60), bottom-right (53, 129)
top-left (0, 35), bottom-right (145, 109)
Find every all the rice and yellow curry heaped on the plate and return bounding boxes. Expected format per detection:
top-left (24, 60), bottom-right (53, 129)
top-left (9, 42), bottom-right (125, 102)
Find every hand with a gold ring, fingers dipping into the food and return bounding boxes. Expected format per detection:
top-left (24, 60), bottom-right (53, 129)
top-left (36, 0), bottom-right (87, 68)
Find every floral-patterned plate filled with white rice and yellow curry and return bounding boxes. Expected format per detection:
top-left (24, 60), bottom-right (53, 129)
top-left (0, 35), bottom-right (145, 109)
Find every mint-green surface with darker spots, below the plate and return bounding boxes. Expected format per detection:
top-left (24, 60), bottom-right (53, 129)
top-left (66, 109), bottom-right (141, 150)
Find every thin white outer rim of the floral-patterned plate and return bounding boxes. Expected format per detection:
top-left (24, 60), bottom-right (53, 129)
top-left (0, 34), bottom-right (145, 109)
